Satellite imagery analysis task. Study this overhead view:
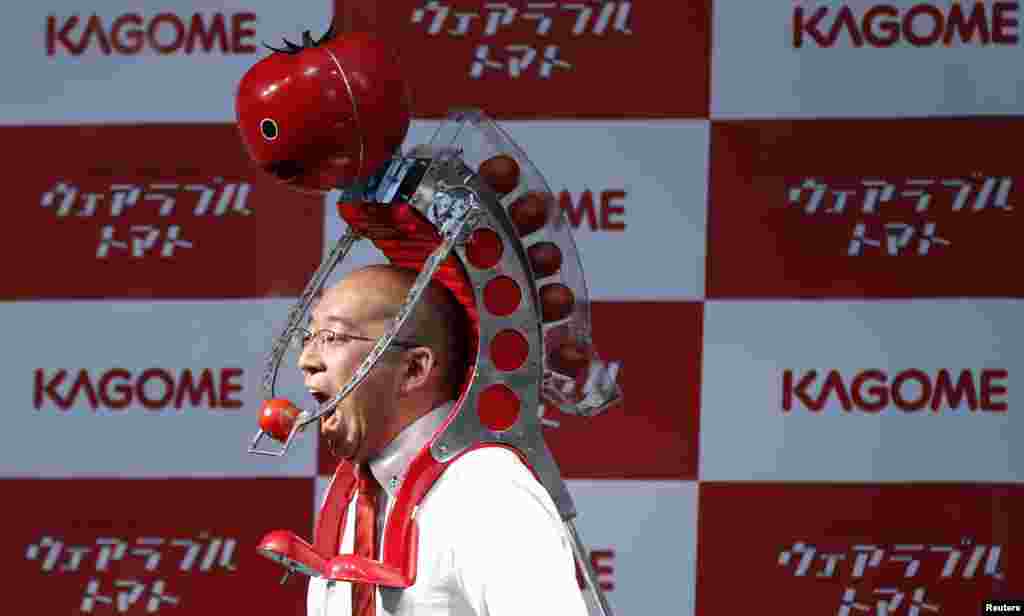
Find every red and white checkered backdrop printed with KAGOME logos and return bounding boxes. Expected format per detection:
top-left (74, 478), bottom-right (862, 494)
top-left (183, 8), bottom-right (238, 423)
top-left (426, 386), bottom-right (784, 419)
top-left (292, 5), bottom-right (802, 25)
top-left (0, 0), bottom-right (1024, 616)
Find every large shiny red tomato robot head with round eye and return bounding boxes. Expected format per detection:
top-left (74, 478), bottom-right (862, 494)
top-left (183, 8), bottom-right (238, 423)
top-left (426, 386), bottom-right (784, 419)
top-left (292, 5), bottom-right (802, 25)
top-left (236, 27), bottom-right (410, 194)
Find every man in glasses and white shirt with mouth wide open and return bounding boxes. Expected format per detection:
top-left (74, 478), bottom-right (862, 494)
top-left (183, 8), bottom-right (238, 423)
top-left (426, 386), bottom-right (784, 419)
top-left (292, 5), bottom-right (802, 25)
top-left (299, 265), bottom-right (587, 616)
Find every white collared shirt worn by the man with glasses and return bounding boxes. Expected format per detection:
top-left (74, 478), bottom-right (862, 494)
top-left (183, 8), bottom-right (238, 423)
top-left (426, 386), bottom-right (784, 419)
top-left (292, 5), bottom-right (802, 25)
top-left (306, 402), bottom-right (588, 616)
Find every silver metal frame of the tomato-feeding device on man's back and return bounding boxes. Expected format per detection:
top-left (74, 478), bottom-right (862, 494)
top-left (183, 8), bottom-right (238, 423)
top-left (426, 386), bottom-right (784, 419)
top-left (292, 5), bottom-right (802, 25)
top-left (250, 124), bottom-right (617, 616)
